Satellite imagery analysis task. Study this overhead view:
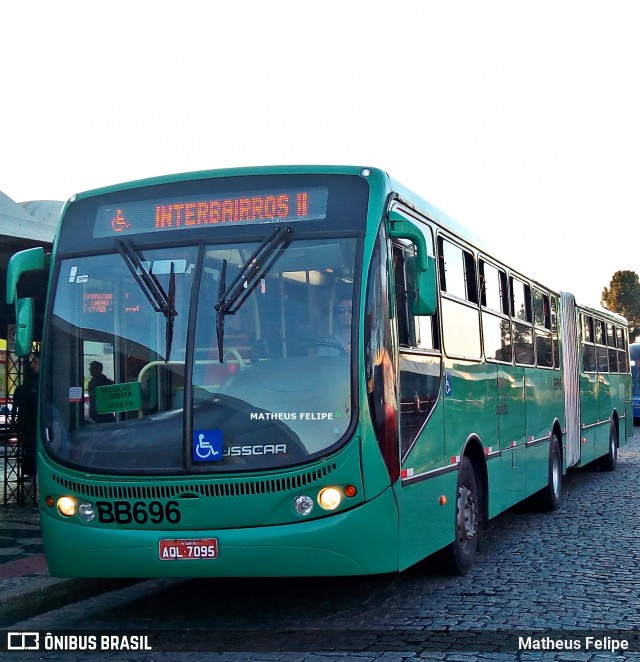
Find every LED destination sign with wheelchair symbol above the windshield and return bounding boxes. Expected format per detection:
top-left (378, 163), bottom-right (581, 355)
top-left (93, 187), bottom-right (329, 238)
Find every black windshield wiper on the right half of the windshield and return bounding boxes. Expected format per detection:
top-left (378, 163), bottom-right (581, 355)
top-left (214, 225), bottom-right (293, 363)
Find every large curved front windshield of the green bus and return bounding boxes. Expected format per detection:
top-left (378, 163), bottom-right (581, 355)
top-left (42, 232), bottom-right (356, 474)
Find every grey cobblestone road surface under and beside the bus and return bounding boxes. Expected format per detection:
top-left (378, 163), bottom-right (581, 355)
top-left (11, 430), bottom-right (640, 662)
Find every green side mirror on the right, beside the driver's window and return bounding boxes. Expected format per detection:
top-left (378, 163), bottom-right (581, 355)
top-left (389, 211), bottom-right (436, 315)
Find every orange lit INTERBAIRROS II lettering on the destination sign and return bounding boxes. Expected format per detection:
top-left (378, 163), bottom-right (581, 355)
top-left (155, 193), bottom-right (296, 229)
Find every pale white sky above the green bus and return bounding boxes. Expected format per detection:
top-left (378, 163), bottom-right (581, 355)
top-left (0, 0), bottom-right (640, 305)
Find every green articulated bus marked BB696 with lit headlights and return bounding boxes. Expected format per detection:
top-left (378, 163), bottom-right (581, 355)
top-left (7, 166), bottom-right (633, 577)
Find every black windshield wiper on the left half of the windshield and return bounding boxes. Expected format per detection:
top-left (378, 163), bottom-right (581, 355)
top-left (116, 239), bottom-right (178, 363)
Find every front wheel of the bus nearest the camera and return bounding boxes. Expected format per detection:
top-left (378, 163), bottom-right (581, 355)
top-left (440, 456), bottom-right (480, 575)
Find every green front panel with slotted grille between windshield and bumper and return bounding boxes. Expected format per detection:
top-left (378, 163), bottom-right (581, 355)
top-left (38, 438), bottom-right (370, 534)
